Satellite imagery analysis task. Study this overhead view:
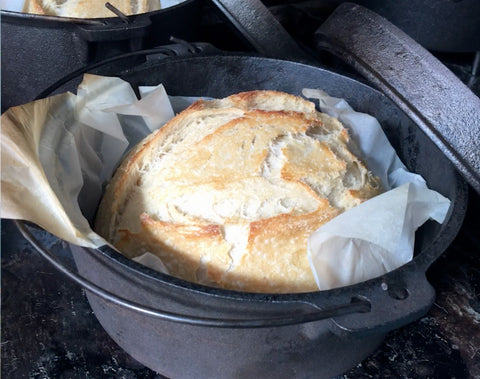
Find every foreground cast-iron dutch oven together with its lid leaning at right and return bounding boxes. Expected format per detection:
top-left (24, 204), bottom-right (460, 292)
top-left (17, 4), bottom-right (480, 378)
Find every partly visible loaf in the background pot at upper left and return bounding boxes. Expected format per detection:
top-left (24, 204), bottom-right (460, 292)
top-left (23, 0), bottom-right (160, 18)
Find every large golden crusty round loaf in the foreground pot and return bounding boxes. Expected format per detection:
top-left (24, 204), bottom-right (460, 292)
top-left (95, 91), bottom-right (380, 293)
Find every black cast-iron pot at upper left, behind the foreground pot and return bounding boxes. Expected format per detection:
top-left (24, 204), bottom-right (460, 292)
top-left (0, 0), bottom-right (203, 112)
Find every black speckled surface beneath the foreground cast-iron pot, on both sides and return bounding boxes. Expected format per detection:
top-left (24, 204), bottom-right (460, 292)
top-left (1, 191), bottom-right (480, 379)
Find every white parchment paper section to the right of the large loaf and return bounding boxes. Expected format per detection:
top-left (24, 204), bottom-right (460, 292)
top-left (303, 89), bottom-right (450, 289)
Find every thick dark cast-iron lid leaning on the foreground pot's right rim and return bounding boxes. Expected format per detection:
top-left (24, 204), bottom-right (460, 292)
top-left (315, 3), bottom-right (480, 193)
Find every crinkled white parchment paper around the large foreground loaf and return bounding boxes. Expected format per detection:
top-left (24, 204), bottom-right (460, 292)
top-left (1, 75), bottom-right (450, 290)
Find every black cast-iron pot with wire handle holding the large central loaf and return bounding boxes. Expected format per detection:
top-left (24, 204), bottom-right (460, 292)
top-left (18, 3), bottom-right (480, 378)
